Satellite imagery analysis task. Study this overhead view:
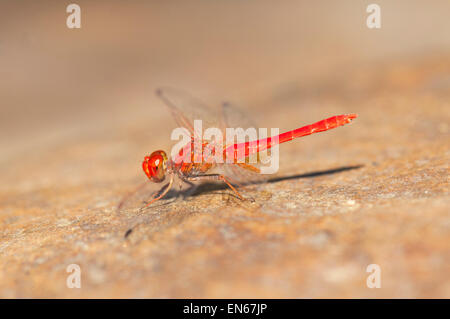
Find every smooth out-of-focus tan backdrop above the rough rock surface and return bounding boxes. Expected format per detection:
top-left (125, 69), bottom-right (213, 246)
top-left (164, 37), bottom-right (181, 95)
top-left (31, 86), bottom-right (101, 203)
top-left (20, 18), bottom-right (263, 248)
top-left (0, 1), bottom-right (450, 162)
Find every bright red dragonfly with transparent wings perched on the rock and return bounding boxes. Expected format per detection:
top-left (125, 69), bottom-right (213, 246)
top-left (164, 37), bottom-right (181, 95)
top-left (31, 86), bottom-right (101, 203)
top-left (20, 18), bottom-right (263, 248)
top-left (118, 88), bottom-right (357, 209)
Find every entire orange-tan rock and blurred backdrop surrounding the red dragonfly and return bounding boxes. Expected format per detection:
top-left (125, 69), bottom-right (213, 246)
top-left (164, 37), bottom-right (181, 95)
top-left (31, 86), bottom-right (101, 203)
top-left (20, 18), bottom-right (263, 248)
top-left (0, 0), bottom-right (450, 297)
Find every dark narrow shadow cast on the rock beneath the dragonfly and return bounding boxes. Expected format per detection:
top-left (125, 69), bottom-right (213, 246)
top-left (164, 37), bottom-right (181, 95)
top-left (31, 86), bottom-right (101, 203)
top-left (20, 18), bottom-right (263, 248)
top-left (191, 165), bottom-right (364, 196)
